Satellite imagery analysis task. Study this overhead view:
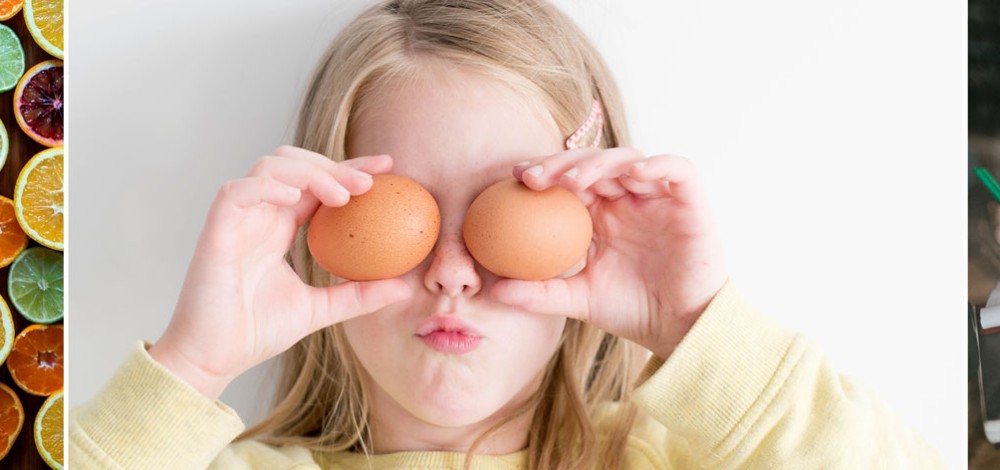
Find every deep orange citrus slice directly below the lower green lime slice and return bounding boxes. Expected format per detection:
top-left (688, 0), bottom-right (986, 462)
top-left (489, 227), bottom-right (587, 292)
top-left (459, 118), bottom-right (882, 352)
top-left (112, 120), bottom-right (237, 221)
top-left (7, 325), bottom-right (63, 396)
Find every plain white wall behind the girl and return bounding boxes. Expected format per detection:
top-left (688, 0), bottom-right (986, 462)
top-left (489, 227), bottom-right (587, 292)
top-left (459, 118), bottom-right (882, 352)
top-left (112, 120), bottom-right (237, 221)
top-left (67, 0), bottom-right (967, 468)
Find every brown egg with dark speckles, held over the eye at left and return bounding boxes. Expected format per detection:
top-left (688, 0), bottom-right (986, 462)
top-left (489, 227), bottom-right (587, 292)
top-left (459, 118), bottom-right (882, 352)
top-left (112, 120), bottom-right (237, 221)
top-left (306, 175), bottom-right (441, 281)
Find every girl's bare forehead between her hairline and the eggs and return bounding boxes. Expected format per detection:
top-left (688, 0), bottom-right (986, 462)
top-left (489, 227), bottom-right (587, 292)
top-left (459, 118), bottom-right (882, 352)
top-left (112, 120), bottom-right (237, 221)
top-left (347, 62), bottom-right (563, 184)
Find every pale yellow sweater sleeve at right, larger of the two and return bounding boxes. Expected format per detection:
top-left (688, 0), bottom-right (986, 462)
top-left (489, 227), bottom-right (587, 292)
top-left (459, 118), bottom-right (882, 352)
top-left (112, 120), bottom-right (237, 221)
top-left (633, 283), bottom-right (946, 469)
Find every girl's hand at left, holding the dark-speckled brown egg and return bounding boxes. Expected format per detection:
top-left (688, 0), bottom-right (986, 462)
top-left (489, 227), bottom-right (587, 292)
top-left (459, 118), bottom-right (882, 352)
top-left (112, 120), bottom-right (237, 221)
top-left (149, 147), bottom-right (410, 399)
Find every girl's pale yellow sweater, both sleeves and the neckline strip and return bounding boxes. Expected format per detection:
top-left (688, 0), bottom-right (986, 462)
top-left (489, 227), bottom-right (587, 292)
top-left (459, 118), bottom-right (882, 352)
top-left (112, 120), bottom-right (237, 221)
top-left (69, 284), bottom-right (946, 470)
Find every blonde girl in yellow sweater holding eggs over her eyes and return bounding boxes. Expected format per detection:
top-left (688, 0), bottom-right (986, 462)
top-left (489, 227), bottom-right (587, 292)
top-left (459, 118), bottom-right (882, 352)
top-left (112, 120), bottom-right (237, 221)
top-left (69, 0), bottom-right (942, 469)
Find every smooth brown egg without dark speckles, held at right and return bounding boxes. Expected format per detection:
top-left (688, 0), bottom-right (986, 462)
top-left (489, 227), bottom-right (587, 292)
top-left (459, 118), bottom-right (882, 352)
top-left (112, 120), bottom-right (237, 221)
top-left (463, 179), bottom-right (593, 281)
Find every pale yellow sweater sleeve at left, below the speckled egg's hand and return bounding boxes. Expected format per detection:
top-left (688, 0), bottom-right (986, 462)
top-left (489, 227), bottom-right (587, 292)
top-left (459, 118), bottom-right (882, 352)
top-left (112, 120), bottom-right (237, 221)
top-left (68, 343), bottom-right (243, 469)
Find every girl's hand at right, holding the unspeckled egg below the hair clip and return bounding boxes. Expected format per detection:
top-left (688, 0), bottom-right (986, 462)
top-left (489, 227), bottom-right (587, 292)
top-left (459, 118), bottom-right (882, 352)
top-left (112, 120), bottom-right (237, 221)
top-left (491, 148), bottom-right (727, 359)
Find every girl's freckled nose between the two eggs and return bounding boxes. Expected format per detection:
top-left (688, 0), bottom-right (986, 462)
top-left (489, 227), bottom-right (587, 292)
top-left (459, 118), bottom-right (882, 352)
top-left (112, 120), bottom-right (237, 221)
top-left (424, 233), bottom-right (482, 297)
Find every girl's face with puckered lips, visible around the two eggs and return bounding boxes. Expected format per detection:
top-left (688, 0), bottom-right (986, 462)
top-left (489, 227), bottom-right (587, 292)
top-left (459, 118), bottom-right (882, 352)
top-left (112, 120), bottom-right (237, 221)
top-left (344, 63), bottom-right (566, 444)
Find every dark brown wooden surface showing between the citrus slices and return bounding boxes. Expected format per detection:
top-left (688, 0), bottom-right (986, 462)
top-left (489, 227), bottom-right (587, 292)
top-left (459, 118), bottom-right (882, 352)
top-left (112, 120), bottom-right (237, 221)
top-left (0, 7), bottom-right (55, 469)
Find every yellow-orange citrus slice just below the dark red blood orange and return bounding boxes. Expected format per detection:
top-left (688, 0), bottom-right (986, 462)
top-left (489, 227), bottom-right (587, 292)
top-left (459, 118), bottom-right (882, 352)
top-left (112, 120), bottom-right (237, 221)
top-left (14, 147), bottom-right (65, 250)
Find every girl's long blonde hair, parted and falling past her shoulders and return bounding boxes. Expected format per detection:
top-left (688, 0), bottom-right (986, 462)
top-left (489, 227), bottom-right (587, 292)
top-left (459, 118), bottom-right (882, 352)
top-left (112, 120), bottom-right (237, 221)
top-left (242, 0), bottom-right (647, 469)
